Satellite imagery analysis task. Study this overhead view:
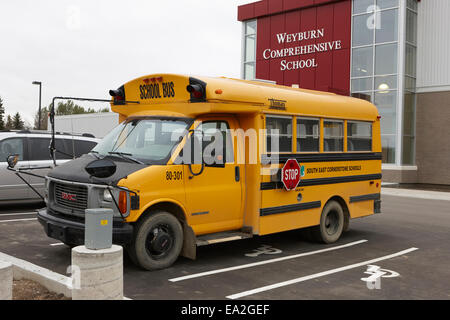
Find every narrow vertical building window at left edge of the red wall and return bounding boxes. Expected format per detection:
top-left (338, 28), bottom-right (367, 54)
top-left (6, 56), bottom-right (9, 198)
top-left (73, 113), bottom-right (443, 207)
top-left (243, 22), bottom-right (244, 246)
top-left (242, 20), bottom-right (256, 80)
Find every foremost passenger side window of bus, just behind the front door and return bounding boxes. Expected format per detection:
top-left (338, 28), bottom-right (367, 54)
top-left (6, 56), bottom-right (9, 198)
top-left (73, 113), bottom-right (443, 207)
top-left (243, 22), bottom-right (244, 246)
top-left (266, 116), bottom-right (292, 152)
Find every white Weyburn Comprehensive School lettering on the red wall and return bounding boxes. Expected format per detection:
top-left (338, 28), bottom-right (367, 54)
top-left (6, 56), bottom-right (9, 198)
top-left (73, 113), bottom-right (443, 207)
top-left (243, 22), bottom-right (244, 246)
top-left (263, 28), bottom-right (342, 71)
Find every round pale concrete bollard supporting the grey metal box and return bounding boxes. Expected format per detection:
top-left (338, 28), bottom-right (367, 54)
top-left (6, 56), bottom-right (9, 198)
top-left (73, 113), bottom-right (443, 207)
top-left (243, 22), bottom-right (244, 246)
top-left (72, 245), bottom-right (123, 300)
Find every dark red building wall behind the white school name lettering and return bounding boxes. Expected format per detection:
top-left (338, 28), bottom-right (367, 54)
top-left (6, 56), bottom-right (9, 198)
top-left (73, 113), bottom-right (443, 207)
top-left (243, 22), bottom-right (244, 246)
top-left (255, 0), bottom-right (351, 94)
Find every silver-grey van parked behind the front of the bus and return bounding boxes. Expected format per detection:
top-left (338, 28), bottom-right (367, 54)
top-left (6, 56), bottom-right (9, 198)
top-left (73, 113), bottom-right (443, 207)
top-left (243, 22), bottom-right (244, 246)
top-left (0, 130), bottom-right (100, 203)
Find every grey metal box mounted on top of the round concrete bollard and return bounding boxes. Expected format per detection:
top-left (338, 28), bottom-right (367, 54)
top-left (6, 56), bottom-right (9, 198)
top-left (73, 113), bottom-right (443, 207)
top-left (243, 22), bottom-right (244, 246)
top-left (84, 208), bottom-right (113, 250)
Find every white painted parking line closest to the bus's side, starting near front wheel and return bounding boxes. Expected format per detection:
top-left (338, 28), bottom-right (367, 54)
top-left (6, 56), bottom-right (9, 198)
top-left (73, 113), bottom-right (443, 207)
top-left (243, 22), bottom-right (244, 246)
top-left (169, 240), bottom-right (367, 282)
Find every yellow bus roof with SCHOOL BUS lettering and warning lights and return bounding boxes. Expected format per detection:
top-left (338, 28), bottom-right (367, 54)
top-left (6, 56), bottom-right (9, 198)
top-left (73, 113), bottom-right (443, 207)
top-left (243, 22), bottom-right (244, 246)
top-left (110, 74), bottom-right (378, 121)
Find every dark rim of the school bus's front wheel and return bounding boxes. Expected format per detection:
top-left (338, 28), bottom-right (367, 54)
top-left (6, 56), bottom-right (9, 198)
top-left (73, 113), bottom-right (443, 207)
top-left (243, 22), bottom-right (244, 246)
top-left (145, 224), bottom-right (175, 260)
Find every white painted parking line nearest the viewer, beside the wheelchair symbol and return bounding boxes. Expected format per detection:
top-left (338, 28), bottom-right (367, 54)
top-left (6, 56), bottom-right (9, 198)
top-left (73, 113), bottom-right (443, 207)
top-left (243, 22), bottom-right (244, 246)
top-left (226, 248), bottom-right (418, 299)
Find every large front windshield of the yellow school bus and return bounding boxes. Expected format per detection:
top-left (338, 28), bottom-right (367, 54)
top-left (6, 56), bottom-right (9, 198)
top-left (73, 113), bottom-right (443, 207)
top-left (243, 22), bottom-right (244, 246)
top-left (92, 118), bottom-right (191, 164)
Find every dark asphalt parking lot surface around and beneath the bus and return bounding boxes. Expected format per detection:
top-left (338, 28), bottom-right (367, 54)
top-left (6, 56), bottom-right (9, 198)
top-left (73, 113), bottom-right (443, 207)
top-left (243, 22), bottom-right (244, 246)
top-left (0, 195), bottom-right (450, 300)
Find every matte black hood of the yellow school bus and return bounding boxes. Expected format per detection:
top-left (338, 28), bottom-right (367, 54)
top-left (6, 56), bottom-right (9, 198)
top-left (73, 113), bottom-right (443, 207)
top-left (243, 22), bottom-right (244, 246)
top-left (48, 154), bottom-right (148, 184)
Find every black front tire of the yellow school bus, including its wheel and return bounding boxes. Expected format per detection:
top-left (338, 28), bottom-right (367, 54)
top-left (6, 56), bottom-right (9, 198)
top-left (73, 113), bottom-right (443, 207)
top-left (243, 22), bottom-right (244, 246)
top-left (128, 211), bottom-right (183, 270)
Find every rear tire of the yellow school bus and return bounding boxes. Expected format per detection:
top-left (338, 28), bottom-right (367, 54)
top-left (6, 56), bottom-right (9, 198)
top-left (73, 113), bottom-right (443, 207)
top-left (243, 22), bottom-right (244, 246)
top-left (311, 201), bottom-right (345, 243)
